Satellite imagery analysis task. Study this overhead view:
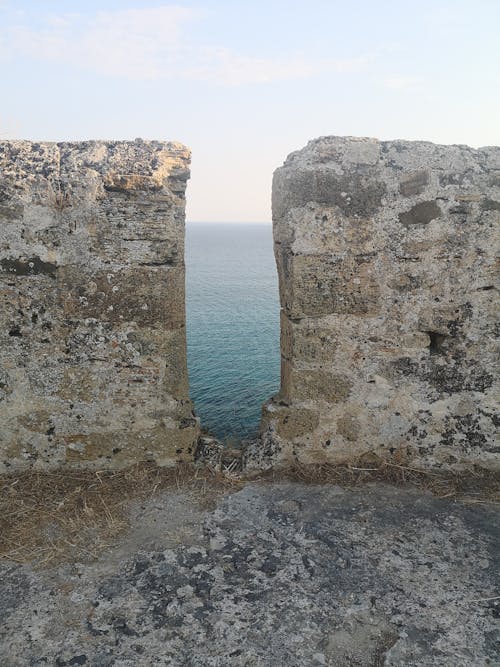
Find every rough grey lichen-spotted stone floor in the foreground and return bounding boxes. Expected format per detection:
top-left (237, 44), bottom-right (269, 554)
top-left (0, 483), bottom-right (500, 667)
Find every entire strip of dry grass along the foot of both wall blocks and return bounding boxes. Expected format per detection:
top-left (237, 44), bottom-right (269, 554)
top-left (0, 457), bottom-right (500, 567)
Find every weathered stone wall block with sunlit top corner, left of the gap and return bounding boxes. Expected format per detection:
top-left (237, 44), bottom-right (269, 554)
top-left (0, 140), bottom-right (198, 469)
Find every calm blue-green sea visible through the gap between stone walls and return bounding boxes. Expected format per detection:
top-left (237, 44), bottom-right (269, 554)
top-left (186, 223), bottom-right (280, 440)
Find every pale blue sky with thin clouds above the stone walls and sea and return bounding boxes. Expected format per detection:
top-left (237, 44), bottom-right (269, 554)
top-left (0, 0), bottom-right (500, 222)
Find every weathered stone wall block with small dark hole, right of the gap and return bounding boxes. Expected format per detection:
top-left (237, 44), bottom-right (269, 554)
top-left (259, 137), bottom-right (500, 468)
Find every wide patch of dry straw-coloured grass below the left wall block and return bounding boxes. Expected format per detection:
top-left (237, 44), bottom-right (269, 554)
top-left (0, 463), bottom-right (241, 567)
